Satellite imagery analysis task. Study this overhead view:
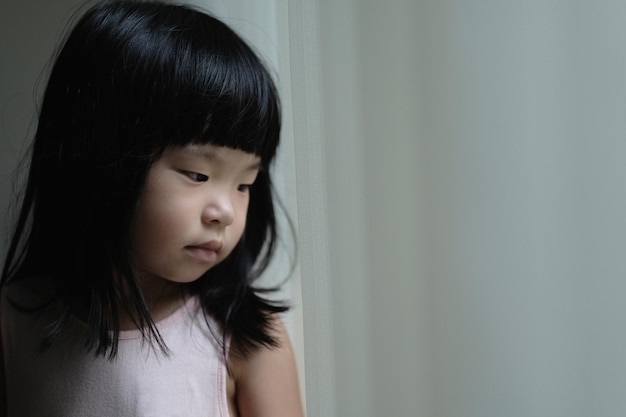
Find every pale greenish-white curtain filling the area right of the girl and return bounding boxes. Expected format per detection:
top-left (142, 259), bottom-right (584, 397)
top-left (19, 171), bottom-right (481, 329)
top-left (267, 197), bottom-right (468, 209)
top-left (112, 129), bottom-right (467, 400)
top-left (299, 0), bottom-right (626, 417)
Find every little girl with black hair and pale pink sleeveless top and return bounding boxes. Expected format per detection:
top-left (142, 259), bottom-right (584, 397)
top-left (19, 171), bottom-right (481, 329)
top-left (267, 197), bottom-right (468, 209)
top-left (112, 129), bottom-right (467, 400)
top-left (0, 1), bottom-right (302, 417)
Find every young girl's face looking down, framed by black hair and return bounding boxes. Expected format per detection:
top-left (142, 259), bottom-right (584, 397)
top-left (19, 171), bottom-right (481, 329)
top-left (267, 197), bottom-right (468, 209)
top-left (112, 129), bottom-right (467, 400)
top-left (133, 144), bottom-right (260, 283)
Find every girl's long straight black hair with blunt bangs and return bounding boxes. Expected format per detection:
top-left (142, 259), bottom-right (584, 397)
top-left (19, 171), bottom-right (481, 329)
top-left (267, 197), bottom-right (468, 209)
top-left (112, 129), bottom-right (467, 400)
top-left (2, 0), bottom-right (287, 357)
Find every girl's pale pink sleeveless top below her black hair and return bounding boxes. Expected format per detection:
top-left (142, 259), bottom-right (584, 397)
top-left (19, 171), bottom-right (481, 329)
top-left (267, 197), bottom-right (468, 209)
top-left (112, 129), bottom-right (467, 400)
top-left (2, 290), bottom-right (229, 417)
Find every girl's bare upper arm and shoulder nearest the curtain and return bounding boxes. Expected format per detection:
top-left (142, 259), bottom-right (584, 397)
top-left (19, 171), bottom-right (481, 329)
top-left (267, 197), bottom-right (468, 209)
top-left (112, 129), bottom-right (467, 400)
top-left (229, 318), bottom-right (304, 417)
